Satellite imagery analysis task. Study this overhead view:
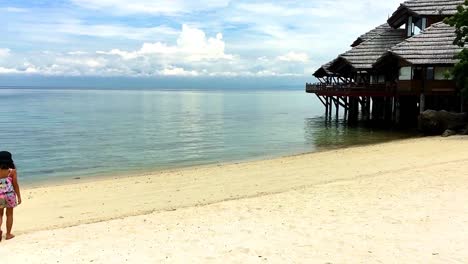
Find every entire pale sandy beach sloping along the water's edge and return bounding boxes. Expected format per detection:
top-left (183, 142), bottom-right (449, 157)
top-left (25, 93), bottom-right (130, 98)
top-left (0, 137), bottom-right (468, 264)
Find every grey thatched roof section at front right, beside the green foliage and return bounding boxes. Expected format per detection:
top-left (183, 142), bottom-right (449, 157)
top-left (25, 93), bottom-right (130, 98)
top-left (384, 22), bottom-right (461, 65)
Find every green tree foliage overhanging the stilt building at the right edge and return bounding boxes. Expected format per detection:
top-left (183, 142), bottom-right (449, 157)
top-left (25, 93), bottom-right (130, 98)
top-left (445, 0), bottom-right (468, 99)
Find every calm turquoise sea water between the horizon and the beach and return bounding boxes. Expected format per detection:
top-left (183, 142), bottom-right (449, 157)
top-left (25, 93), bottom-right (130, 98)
top-left (0, 89), bottom-right (411, 183)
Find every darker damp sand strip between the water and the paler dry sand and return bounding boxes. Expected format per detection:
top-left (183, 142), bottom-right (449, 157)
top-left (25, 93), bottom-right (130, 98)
top-left (11, 137), bottom-right (460, 234)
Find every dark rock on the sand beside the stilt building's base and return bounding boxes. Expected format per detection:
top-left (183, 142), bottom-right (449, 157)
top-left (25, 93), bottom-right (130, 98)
top-left (419, 110), bottom-right (468, 135)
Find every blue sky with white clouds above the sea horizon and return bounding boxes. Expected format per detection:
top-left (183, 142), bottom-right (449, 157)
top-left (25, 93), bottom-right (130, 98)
top-left (0, 0), bottom-right (401, 86)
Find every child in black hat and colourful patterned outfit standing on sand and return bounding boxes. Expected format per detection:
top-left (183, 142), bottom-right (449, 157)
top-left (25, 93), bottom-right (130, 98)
top-left (0, 151), bottom-right (21, 241)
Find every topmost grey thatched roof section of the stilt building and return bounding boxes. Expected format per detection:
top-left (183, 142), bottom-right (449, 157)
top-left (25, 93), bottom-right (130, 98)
top-left (388, 0), bottom-right (465, 28)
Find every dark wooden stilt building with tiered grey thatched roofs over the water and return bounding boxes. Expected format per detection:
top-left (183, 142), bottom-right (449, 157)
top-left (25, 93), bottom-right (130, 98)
top-left (306, 0), bottom-right (464, 123)
